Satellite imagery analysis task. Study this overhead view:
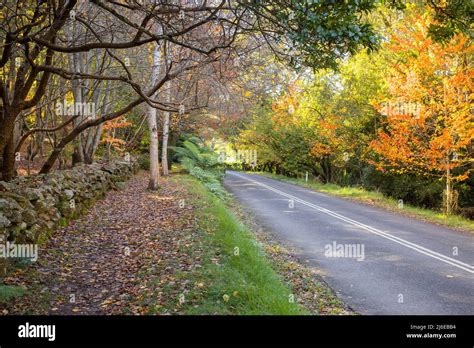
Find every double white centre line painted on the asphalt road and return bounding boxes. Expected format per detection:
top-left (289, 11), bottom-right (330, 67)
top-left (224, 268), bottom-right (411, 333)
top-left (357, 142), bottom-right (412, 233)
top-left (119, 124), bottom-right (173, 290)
top-left (229, 172), bottom-right (474, 273)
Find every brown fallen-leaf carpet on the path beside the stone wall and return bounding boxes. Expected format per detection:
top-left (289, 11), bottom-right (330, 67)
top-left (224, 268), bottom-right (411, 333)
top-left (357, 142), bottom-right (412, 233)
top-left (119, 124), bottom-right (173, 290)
top-left (0, 172), bottom-right (194, 315)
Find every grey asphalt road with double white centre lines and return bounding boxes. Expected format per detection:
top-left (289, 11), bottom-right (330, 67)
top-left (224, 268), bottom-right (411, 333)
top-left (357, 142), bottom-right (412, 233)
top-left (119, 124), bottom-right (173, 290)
top-left (225, 171), bottom-right (474, 315)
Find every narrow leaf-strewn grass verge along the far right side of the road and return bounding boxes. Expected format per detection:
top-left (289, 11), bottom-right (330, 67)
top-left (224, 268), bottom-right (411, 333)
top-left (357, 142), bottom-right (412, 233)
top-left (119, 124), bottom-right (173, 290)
top-left (254, 172), bottom-right (474, 233)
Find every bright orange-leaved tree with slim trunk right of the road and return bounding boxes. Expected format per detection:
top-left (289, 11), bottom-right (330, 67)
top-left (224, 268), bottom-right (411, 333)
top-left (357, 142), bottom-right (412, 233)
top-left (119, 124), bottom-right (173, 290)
top-left (370, 15), bottom-right (474, 214)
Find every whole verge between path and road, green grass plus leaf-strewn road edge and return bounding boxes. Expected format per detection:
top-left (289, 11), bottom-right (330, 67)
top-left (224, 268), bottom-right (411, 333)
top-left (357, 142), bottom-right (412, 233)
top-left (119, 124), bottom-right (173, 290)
top-left (155, 175), bottom-right (353, 315)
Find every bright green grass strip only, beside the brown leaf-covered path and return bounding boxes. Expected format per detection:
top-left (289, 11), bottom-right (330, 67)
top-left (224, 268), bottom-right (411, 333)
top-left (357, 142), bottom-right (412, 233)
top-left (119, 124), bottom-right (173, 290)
top-left (169, 175), bottom-right (309, 315)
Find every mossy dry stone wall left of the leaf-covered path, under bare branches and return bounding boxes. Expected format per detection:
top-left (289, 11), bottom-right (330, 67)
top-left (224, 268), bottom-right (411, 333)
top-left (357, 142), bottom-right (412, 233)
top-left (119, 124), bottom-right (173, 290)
top-left (0, 161), bottom-right (139, 244)
